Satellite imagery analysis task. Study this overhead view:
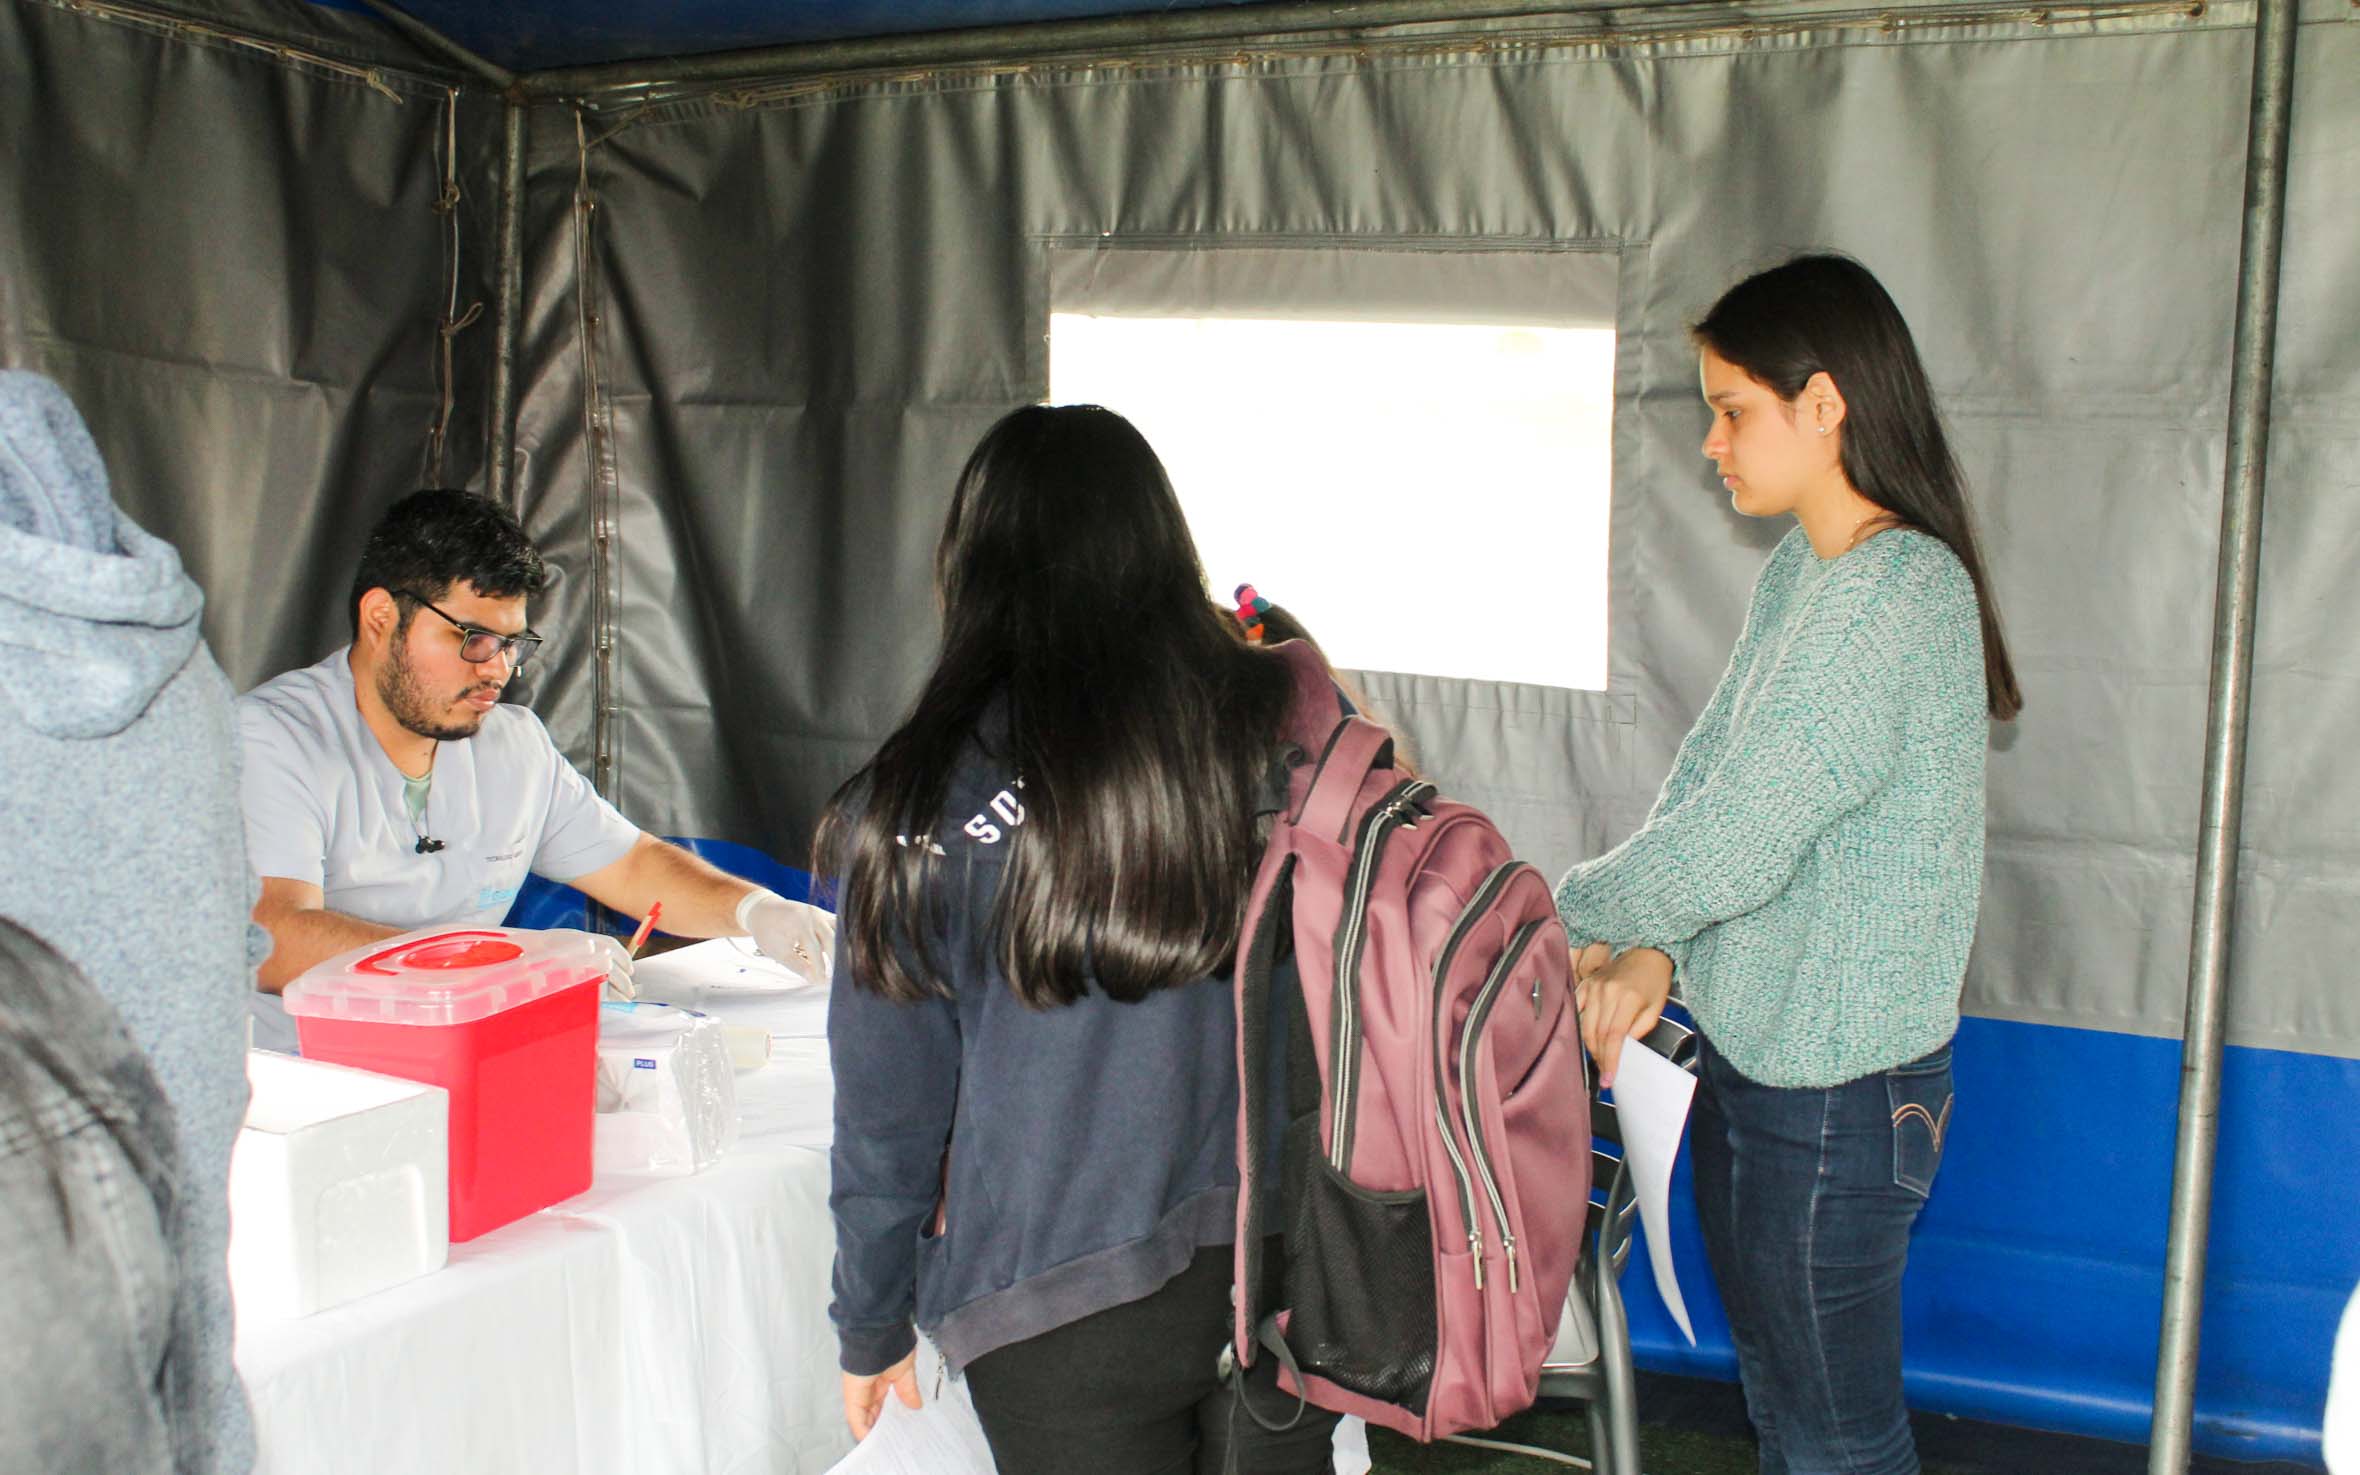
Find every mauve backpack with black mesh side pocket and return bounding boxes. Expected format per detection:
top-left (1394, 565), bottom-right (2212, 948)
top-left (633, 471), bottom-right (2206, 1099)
top-left (1230, 644), bottom-right (1591, 1440)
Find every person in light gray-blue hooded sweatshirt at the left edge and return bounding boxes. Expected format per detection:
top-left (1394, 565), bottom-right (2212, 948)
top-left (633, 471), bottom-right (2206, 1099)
top-left (0, 373), bottom-right (269, 1473)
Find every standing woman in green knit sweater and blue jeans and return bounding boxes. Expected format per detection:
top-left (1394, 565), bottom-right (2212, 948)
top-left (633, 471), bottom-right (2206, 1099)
top-left (1558, 255), bottom-right (2023, 1475)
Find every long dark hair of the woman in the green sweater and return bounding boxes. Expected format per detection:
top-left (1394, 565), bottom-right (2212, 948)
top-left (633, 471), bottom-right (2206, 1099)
top-left (1690, 255), bottom-right (2025, 722)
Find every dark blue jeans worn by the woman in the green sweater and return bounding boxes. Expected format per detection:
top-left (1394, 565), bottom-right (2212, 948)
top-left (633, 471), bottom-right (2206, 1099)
top-left (1690, 1041), bottom-right (1952, 1475)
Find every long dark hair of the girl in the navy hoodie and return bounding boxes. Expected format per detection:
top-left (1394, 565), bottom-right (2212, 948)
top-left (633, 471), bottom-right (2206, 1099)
top-left (814, 406), bottom-right (1293, 1008)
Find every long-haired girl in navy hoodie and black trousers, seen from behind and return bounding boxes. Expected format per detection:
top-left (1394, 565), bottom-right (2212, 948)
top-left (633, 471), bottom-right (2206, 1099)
top-left (819, 406), bottom-right (1333, 1475)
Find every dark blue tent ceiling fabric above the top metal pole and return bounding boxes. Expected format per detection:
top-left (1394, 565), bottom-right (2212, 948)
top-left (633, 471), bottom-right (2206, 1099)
top-left (328, 0), bottom-right (1274, 71)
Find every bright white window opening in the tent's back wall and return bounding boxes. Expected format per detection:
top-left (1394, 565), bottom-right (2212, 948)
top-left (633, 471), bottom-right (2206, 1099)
top-left (1050, 314), bottom-right (1614, 691)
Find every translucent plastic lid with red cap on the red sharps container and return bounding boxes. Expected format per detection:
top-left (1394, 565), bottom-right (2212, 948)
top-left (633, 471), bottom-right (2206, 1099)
top-left (286, 927), bottom-right (607, 1024)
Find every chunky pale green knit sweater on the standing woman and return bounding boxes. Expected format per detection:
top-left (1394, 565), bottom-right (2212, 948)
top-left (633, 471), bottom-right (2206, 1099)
top-left (1558, 529), bottom-right (1987, 1086)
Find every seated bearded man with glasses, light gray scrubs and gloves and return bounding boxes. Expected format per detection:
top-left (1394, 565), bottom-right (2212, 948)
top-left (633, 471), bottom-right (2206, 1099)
top-left (238, 491), bottom-right (835, 1048)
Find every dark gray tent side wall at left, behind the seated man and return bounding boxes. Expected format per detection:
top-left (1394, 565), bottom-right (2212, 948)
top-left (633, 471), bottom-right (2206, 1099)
top-left (0, 0), bottom-right (500, 687)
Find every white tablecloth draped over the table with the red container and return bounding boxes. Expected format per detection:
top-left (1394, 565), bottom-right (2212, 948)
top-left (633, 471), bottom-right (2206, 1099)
top-left (238, 942), bottom-right (1369, 1475)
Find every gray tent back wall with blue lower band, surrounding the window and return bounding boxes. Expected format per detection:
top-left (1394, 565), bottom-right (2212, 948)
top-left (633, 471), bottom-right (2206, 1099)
top-left (517, 5), bottom-right (2360, 1454)
